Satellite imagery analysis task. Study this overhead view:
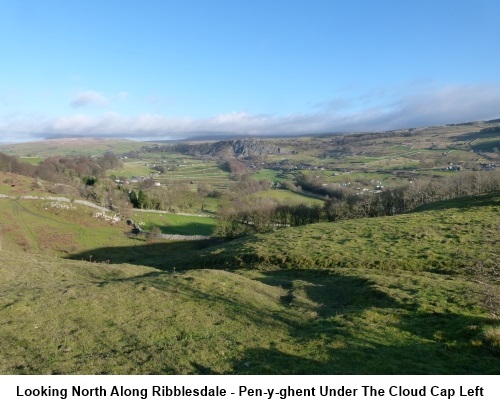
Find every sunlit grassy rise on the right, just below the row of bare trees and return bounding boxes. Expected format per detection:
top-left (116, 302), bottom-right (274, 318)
top-left (190, 192), bottom-right (500, 274)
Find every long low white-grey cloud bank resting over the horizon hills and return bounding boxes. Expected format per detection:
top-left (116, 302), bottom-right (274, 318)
top-left (0, 85), bottom-right (500, 142)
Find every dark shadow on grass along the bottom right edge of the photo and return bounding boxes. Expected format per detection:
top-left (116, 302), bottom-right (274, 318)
top-left (229, 315), bottom-right (500, 375)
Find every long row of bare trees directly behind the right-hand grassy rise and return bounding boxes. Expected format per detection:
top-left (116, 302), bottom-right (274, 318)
top-left (216, 171), bottom-right (500, 237)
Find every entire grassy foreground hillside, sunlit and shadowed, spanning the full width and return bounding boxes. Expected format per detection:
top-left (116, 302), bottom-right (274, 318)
top-left (0, 189), bottom-right (500, 374)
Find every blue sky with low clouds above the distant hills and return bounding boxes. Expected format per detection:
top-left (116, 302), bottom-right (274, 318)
top-left (0, 0), bottom-right (500, 142)
